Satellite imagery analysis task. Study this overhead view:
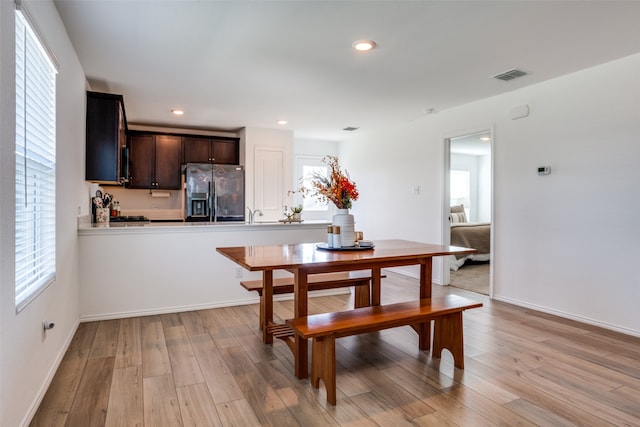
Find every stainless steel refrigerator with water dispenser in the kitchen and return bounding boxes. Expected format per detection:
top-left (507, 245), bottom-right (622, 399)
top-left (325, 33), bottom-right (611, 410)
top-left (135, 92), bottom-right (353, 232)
top-left (185, 163), bottom-right (245, 222)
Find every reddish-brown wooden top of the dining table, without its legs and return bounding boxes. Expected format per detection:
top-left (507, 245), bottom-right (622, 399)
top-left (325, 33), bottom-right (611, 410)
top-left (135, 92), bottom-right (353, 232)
top-left (217, 240), bottom-right (476, 271)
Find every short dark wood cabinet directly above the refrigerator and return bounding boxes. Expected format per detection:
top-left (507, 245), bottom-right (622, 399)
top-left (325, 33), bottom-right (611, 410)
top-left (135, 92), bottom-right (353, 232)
top-left (184, 136), bottom-right (240, 165)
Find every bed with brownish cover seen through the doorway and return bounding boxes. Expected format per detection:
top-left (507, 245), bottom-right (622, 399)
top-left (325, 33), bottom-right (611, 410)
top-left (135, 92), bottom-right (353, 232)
top-left (449, 205), bottom-right (491, 271)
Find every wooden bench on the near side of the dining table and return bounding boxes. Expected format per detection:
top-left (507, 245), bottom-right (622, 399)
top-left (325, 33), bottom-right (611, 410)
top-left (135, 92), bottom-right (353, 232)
top-left (287, 295), bottom-right (482, 405)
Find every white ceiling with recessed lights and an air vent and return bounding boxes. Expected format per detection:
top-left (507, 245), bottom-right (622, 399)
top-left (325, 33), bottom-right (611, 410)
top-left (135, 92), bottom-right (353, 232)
top-left (54, 0), bottom-right (640, 140)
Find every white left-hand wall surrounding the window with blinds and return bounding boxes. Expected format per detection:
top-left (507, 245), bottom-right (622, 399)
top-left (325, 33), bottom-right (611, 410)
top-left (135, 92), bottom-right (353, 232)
top-left (0, 1), bottom-right (88, 426)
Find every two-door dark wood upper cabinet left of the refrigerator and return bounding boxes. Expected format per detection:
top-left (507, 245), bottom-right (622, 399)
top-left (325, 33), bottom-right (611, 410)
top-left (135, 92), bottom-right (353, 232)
top-left (127, 132), bottom-right (182, 190)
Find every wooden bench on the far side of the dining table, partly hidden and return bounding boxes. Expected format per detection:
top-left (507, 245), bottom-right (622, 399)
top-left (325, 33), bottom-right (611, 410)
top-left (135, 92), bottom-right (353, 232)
top-left (240, 271), bottom-right (386, 325)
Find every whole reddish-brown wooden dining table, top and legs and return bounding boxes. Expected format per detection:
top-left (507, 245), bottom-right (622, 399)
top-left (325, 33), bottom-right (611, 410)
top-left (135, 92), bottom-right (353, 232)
top-left (216, 240), bottom-right (475, 378)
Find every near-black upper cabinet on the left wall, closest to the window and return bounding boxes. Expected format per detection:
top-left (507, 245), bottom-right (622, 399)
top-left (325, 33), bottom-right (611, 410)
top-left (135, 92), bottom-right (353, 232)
top-left (85, 92), bottom-right (127, 185)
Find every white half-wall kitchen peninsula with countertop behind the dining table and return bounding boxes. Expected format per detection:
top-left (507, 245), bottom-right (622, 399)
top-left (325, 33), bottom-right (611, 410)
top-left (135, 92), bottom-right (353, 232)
top-left (78, 221), bottom-right (327, 321)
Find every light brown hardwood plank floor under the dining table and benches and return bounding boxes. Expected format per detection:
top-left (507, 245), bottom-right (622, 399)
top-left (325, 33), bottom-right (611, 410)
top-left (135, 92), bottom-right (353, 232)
top-left (31, 273), bottom-right (640, 427)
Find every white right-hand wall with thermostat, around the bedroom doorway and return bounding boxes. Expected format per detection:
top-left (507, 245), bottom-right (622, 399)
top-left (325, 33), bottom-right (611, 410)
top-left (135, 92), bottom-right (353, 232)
top-left (340, 54), bottom-right (640, 335)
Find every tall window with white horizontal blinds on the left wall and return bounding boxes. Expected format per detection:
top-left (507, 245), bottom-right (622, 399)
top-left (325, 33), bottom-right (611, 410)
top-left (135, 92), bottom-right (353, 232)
top-left (15, 6), bottom-right (56, 310)
